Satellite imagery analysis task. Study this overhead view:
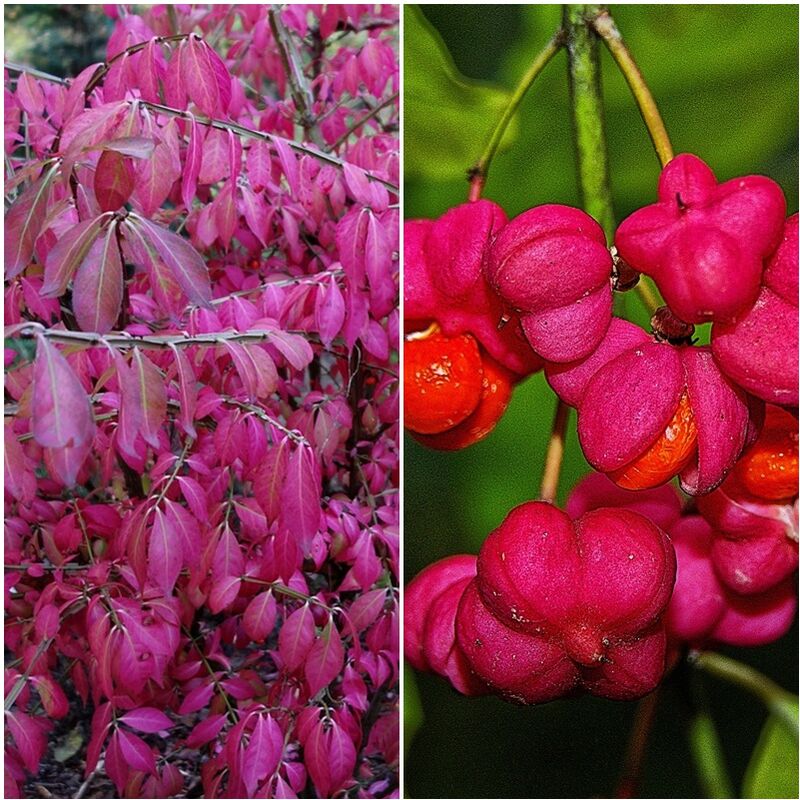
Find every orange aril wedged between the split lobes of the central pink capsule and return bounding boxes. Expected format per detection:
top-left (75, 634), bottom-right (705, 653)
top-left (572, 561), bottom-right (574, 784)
top-left (609, 393), bottom-right (697, 489)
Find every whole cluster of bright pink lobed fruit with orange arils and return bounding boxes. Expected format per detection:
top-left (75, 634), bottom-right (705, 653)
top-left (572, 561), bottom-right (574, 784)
top-left (405, 155), bottom-right (798, 703)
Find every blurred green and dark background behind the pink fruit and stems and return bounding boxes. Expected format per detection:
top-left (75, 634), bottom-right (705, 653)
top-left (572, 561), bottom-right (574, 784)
top-left (404, 5), bottom-right (798, 797)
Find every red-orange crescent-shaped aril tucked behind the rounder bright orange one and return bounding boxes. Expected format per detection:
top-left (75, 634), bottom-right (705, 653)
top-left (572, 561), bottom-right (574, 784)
top-left (414, 353), bottom-right (515, 450)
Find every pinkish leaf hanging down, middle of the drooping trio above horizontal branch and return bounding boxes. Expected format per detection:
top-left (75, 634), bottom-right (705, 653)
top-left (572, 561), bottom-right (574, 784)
top-left (72, 224), bottom-right (123, 333)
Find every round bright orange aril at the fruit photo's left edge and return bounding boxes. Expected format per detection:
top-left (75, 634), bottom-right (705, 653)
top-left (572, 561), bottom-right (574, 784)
top-left (403, 329), bottom-right (483, 434)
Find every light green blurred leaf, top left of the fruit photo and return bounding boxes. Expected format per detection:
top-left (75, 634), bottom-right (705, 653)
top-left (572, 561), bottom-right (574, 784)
top-left (404, 6), bottom-right (518, 180)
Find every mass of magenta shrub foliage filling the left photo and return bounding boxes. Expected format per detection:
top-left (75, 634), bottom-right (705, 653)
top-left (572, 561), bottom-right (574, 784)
top-left (5, 5), bottom-right (399, 797)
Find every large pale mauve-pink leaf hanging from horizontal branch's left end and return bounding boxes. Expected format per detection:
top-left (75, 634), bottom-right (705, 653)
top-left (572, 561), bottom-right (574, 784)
top-left (32, 336), bottom-right (94, 448)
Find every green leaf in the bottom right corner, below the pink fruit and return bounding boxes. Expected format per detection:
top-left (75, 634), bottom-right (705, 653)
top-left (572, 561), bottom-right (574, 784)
top-left (742, 698), bottom-right (798, 798)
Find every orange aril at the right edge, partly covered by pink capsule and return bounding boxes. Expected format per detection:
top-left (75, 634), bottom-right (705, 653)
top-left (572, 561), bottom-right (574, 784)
top-left (735, 406), bottom-right (798, 500)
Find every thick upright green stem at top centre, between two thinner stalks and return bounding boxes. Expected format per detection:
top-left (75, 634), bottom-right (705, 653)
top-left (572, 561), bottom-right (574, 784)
top-left (564, 4), bottom-right (614, 241)
